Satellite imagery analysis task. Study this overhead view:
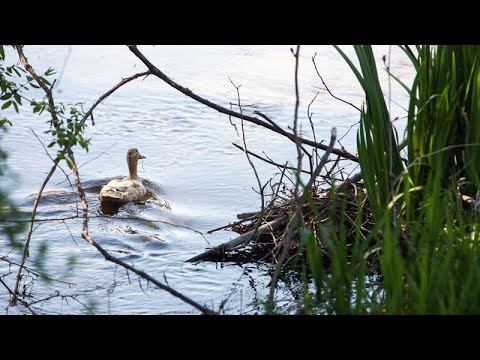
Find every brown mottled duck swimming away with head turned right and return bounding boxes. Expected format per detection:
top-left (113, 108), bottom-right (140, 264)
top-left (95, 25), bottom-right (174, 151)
top-left (100, 149), bottom-right (147, 204)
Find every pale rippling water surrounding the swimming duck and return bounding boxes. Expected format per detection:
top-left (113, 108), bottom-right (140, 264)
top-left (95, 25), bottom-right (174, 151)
top-left (0, 45), bottom-right (412, 314)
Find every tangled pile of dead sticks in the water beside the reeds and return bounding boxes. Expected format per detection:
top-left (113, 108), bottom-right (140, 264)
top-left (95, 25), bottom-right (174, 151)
top-left (187, 175), bottom-right (374, 264)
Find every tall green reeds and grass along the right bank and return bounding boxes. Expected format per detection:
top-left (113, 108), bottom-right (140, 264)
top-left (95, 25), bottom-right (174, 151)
top-left (302, 45), bottom-right (480, 314)
